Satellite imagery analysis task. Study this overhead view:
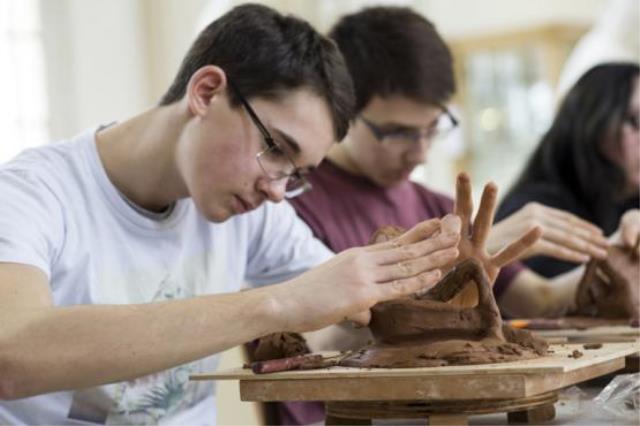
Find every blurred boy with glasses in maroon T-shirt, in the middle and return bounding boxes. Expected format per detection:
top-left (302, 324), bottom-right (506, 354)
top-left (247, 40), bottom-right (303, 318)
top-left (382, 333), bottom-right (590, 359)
top-left (272, 7), bottom-right (606, 424)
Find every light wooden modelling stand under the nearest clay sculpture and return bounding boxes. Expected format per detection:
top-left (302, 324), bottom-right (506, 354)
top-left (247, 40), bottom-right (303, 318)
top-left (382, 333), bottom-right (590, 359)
top-left (191, 342), bottom-right (640, 424)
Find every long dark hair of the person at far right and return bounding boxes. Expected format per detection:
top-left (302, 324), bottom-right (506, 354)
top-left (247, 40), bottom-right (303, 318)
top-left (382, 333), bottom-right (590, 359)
top-left (507, 63), bottom-right (640, 233)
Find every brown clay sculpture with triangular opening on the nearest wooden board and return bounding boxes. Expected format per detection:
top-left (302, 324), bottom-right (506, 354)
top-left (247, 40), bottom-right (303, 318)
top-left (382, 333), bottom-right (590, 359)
top-left (340, 259), bottom-right (547, 368)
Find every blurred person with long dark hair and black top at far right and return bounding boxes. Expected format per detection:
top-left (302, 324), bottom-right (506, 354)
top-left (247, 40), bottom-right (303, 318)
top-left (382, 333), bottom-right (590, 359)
top-left (497, 63), bottom-right (640, 277)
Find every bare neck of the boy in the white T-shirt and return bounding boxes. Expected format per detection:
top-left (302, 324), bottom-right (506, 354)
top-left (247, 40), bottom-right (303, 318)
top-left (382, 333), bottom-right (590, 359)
top-left (96, 102), bottom-right (189, 211)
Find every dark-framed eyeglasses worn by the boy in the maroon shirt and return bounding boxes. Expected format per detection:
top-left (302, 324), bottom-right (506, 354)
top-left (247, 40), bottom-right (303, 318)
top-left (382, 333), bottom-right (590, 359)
top-left (359, 106), bottom-right (459, 143)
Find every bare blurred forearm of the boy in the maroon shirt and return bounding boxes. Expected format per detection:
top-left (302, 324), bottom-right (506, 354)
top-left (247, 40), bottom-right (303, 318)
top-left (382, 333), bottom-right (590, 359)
top-left (498, 266), bottom-right (584, 318)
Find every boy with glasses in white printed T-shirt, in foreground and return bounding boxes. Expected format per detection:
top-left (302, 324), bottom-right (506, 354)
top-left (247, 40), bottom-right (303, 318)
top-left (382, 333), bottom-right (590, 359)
top-left (0, 5), bottom-right (470, 424)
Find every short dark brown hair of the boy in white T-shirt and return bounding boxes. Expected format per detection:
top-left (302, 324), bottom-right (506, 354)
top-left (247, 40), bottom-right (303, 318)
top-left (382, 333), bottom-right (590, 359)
top-left (160, 4), bottom-right (354, 140)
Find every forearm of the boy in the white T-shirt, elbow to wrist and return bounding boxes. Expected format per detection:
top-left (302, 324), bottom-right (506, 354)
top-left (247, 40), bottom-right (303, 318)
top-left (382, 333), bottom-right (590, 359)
top-left (0, 289), bottom-right (279, 398)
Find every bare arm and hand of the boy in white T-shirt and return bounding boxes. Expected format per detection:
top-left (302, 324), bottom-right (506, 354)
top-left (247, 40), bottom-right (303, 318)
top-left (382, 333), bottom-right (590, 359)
top-left (0, 220), bottom-right (459, 399)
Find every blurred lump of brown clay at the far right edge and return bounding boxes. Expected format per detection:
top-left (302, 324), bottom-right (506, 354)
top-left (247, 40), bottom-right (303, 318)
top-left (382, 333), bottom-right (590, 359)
top-left (576, 246), bottom-right (640, 322)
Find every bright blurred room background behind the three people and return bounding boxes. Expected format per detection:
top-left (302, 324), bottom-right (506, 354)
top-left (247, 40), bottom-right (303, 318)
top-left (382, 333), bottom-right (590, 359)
top-left (0, 0), bottom-right (640, 424)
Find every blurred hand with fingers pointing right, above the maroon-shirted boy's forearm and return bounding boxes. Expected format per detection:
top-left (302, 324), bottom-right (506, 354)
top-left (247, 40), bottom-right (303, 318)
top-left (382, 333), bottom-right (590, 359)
top-left (487, 202), bottom-right (608, 263)
